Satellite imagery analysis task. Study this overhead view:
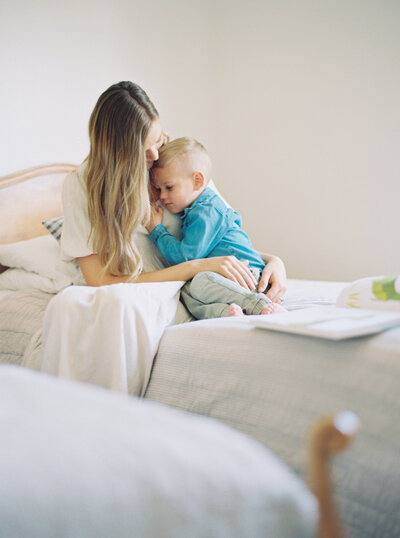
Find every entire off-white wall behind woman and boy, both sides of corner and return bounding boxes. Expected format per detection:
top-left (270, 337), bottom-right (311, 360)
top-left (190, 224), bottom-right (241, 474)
top-left (0, 0), bottom-right (400, 280)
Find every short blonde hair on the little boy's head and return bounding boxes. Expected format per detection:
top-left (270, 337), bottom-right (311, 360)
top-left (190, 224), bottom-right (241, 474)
top-left (153, 136), bottom-right (211, 185)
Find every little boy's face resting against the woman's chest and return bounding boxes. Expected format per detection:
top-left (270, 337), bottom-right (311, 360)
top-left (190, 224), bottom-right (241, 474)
top-left (151, 158), bottom-right (199, 213)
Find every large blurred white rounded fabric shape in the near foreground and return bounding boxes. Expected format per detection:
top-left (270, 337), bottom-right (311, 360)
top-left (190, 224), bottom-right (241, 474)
top-left (0, 366), bottom-right (317, 538)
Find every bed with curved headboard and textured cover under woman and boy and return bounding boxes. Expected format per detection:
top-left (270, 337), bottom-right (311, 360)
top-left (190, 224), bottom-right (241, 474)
top-left (0, 165), bottom-right (400, 538)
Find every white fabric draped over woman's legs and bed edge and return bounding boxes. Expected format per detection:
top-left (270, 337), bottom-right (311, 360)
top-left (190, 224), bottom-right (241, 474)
top-left (39, 282), bottom-right (183, 395)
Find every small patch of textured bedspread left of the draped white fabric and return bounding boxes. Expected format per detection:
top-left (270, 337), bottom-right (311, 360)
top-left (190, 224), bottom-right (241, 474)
top-left (0, 289), bottom-right (54, 365)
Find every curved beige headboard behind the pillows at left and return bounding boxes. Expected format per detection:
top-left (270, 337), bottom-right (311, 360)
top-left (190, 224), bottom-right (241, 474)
top-left (0, 164), bottom-right (76, 244)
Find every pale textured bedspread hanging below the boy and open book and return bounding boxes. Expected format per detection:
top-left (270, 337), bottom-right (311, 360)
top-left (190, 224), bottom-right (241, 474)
top-left (146, 308), bottom-right (400, 538)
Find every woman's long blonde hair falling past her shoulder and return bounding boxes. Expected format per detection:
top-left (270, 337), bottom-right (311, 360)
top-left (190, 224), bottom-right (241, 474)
top-left (86, 82), bottom-right (158, 279)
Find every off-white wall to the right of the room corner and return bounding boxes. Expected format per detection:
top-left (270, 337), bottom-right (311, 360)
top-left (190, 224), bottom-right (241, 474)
top-left (214, 0), bottom-right (400, 280)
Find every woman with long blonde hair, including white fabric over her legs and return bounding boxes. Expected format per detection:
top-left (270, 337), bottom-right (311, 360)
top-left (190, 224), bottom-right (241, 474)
top-left (40, 82), bottom-right (286, 395)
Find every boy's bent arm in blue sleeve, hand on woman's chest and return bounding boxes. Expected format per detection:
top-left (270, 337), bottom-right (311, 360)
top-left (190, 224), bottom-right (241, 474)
top-left (149, 205), bottom-right (228, 264)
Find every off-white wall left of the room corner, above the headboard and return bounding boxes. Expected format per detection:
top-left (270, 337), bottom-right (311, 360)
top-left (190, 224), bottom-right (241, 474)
top-left (0, 0), bottom-right (214, 175)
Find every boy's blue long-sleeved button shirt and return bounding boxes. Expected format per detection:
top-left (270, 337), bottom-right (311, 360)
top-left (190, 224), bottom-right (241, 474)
top-left (149, 188), bottom-right (265, 271)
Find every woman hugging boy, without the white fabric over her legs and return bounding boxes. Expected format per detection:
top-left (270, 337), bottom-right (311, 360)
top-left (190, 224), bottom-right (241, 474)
top-left (61, 82), bottom-right (286, 300)
